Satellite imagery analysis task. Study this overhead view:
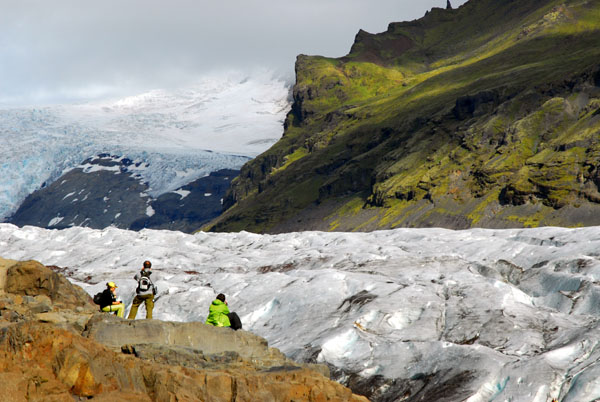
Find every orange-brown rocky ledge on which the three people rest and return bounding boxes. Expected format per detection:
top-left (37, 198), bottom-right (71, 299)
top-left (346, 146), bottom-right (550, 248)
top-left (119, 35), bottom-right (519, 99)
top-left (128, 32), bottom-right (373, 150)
top-left (0, 259), bottom-right (367, 402)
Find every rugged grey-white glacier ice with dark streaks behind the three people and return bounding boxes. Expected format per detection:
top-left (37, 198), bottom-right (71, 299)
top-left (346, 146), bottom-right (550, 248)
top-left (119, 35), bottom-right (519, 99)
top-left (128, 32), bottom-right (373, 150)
top-left (0, 224), bottom-right (600, 402)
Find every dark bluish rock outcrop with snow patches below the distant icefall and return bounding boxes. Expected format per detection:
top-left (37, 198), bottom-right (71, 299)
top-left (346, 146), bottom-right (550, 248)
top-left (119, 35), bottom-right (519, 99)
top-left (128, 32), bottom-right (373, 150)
top-left (7, 155), bottom-right (239, 232)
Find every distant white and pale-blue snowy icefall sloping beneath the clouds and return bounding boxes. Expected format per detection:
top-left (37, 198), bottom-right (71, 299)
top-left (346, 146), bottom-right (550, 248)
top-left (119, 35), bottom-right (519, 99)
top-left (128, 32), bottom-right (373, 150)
top-left (0, 72), bottom-right (289, 220)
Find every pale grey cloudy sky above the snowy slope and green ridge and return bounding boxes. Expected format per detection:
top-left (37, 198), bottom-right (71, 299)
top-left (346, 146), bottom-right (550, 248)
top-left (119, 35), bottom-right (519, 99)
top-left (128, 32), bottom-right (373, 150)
top-left (0, 0), bottom-right (466, 105)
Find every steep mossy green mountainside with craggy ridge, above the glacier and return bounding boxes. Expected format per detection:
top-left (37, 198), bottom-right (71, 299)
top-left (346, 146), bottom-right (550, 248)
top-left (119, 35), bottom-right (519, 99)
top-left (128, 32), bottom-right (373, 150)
top-left (205, 0), bottom-right (600, 232)
